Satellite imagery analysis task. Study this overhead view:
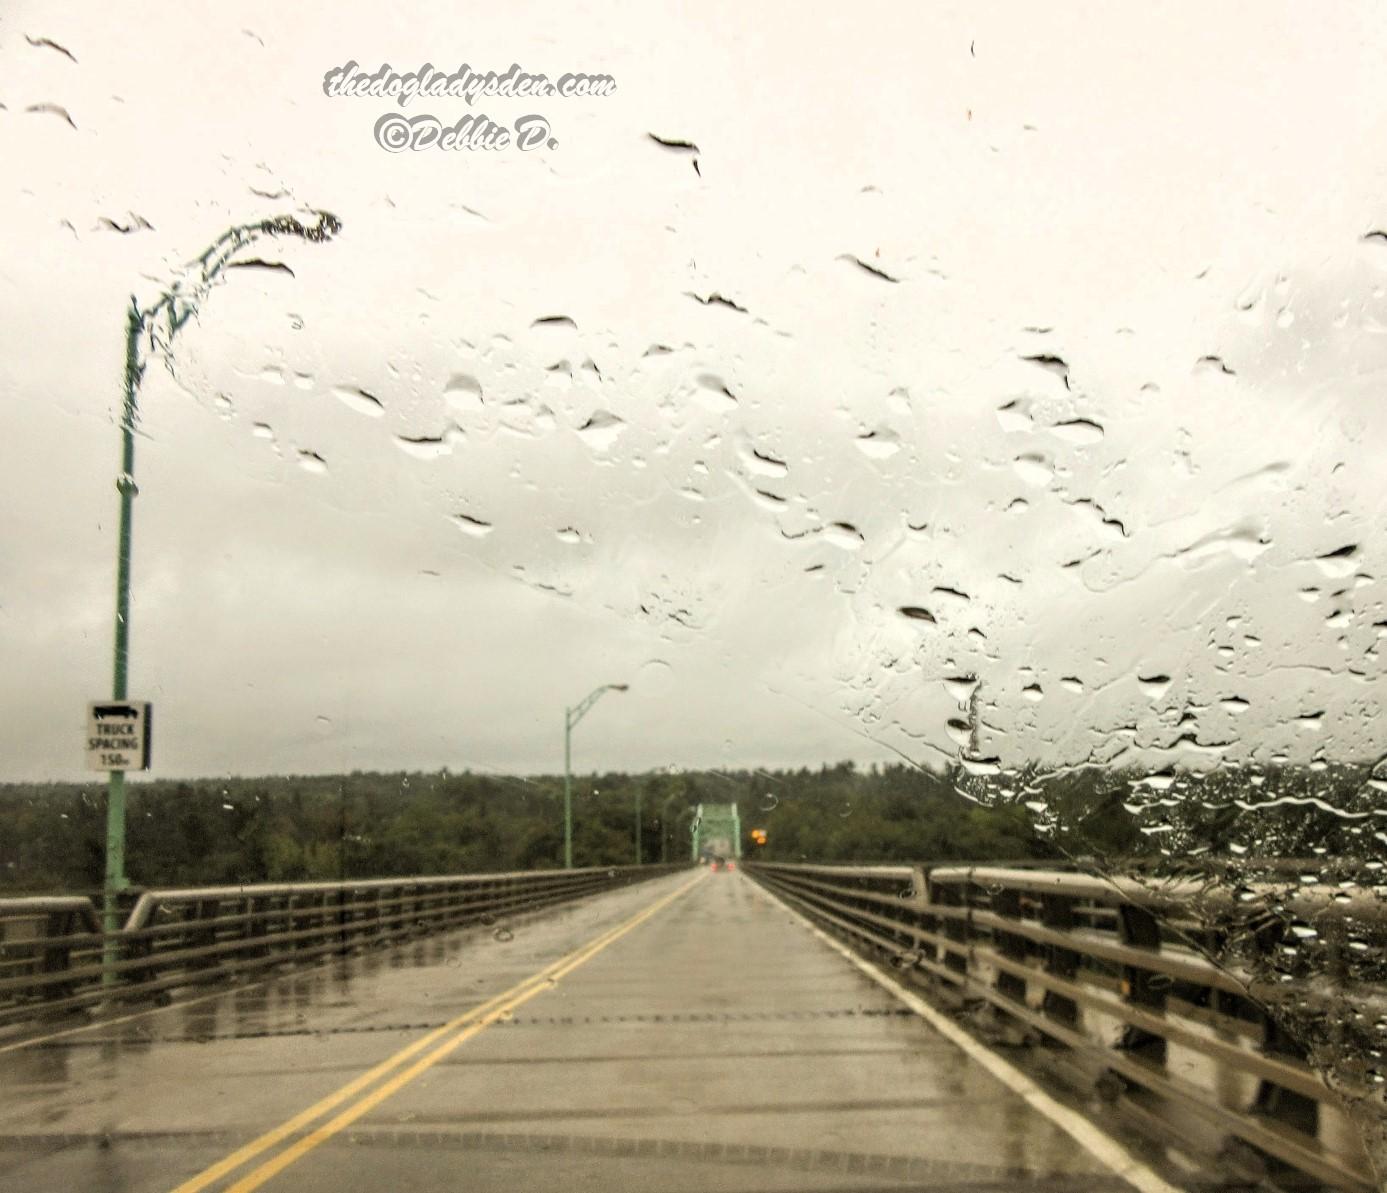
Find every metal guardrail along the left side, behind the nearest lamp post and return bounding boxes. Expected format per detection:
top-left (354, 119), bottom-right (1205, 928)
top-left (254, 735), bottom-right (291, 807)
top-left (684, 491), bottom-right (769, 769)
top-left (0, 866), bottom-right (684, 1025)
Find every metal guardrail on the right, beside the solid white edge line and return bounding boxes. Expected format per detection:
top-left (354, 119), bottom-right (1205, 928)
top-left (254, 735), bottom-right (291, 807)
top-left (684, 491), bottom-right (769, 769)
top-left (745, 863), bottom-right (1387, 1193)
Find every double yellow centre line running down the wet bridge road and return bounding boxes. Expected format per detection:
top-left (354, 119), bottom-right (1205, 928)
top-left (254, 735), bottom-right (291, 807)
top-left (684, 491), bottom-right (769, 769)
top-left (173, 871), bottom-right (707, 1193)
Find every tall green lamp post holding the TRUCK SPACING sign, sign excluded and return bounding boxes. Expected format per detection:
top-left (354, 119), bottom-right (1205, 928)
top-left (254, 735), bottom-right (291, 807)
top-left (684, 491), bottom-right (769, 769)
top-left (103, 211), bottom-right (341, 985)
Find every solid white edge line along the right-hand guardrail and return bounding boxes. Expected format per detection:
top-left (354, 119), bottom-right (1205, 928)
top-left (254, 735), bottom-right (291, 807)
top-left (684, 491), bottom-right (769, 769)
top-left (756, 882), bottom-right (1182, 1193)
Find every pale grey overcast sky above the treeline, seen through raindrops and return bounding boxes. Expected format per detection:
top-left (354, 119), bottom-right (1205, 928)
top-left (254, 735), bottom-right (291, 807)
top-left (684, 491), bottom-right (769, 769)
top-left (0, 0), bottom-right (1387, 778)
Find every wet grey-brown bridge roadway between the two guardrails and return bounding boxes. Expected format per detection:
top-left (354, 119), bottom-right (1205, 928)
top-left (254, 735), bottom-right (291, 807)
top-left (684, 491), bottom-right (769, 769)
top-left (0, 871), bottom-right (1148, 1193)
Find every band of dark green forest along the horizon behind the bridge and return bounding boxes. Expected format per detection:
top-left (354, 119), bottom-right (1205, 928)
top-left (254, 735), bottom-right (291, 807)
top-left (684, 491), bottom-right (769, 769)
top-left (0, 763), bottom-right (1370, 892)
